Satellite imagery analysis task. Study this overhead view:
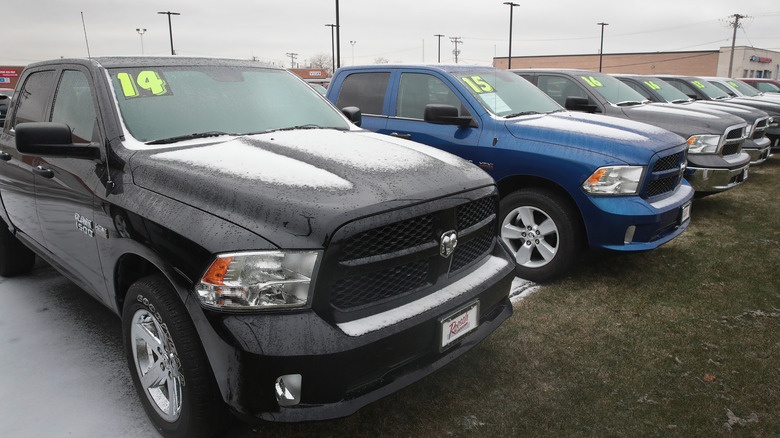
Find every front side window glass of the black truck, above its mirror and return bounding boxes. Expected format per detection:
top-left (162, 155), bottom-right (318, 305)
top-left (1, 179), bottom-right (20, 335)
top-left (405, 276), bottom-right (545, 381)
top-left (51, 70), bottom-right (97, 143)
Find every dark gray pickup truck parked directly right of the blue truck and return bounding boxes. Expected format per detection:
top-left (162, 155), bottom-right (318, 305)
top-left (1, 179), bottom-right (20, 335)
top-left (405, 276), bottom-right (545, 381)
top-left (513, 69), bottom-right (750, 195)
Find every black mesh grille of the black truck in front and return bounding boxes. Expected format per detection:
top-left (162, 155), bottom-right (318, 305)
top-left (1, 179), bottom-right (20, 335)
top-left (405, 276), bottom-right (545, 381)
top-left (322, 195), bottom-right (498, 313)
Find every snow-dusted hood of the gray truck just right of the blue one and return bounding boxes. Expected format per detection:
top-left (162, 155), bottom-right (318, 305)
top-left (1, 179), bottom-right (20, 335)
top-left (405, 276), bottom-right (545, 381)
top-left (621, 103), bottom-right (745, 138)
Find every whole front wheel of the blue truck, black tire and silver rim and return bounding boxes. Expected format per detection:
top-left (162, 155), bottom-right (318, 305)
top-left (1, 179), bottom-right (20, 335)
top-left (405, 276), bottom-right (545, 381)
top-left (499, 188), bottom-right (584, 282)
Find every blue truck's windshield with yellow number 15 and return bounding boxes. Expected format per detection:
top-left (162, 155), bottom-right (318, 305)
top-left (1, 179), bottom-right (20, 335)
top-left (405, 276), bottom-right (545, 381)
top-left (450, 69), bottom-right (564, 117)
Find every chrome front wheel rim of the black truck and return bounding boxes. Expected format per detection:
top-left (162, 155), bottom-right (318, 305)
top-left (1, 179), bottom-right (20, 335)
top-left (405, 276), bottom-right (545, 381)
top-left (130, 309), bottom-right (184, 423)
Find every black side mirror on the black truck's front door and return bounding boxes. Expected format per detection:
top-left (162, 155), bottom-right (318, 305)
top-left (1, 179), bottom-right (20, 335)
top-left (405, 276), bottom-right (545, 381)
top-left (15, 122), bottom-right (100, 160)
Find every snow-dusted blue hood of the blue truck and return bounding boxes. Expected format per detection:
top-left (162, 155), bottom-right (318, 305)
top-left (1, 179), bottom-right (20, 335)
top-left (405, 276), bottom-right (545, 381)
top-left (506, 112), bottom-right (685, 164)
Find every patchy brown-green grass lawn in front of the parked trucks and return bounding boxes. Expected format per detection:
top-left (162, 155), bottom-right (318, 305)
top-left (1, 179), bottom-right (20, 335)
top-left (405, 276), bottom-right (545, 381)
top-left (241, 154), bottom-right (780, 437)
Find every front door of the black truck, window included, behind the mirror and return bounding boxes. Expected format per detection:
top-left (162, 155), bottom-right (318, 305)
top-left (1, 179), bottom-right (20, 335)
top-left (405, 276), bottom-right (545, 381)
top-left (35, 69), bottom-right (105, 299)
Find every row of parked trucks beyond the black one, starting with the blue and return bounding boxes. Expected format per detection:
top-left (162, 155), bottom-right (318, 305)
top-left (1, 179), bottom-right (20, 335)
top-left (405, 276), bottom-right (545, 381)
top-left (327, 65), bottom-right (780, 281)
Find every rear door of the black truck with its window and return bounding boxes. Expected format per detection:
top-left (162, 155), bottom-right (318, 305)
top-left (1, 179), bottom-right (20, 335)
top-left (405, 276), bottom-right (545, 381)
top-left (0, 70), bottom-right (56, 246)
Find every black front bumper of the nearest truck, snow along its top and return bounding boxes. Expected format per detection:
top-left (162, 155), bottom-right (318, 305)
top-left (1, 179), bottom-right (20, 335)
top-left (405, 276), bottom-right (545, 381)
top-left (197, 244), bottom-right (515, 422)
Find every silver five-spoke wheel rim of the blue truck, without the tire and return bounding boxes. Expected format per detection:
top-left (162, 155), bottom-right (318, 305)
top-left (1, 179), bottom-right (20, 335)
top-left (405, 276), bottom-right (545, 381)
top-left (501, 206), bottom-right (560, 268)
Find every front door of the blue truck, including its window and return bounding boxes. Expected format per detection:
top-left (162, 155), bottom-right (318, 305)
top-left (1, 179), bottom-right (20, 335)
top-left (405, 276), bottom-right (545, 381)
top-left (378, 73), bottom-right (482, 164)
